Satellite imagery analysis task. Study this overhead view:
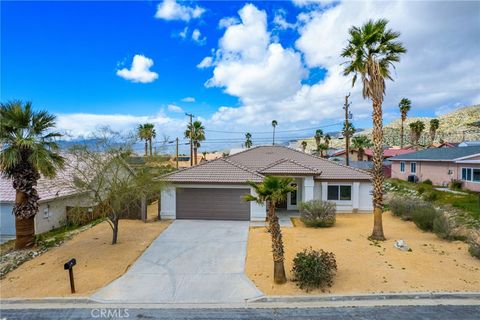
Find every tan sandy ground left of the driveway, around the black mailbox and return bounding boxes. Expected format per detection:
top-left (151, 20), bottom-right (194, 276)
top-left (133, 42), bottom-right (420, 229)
top-left (0, 220), bottom-right (170, 298)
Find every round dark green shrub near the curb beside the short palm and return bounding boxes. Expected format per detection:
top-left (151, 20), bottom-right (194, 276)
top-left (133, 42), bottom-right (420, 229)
top-left (292, 248), bottom-right (337, 292)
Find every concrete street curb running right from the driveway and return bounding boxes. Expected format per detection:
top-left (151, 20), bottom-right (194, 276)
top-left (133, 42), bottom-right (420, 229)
top-left (247, 292), bottom-right (480, 303)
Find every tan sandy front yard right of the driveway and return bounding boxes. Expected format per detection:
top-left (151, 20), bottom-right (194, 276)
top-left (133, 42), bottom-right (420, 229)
top-left (246, 213), bottom-right (480, 295)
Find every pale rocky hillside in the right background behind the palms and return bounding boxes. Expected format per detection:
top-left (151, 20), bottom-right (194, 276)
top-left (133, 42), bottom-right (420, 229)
top-left (297, 105), bottom-right (480, 150)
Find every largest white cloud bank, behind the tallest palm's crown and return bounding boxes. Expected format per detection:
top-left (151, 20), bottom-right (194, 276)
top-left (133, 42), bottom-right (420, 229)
top-left (208, 1), bottom-right (480, 126)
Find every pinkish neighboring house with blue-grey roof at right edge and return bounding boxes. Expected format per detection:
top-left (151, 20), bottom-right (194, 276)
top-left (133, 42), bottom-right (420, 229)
top-left (389, 146), bottom-right (480, 191)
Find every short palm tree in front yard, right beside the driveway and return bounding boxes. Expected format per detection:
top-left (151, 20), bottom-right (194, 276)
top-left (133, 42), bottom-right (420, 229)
top-left (244, 176), bottom-right (296, 284)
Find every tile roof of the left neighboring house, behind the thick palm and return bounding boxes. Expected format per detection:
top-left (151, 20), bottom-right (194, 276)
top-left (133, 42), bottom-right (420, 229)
top-left (0, 155), bottom-right (82, 202)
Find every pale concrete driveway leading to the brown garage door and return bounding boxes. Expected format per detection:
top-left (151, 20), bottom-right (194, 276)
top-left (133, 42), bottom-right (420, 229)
top-left (92, 220), bottom-right (263, 303)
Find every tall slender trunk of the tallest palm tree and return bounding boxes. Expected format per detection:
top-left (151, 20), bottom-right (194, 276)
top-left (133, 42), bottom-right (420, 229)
top-left (370, 100), bottom-right (385, 240)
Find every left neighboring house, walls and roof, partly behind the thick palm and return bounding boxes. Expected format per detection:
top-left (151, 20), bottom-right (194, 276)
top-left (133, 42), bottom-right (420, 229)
top-left (0, 159), bottom-right (91, 238)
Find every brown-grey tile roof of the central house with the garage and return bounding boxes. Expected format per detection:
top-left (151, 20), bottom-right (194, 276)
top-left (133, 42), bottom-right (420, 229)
top-left (162, 146), bottom-right (371, 183)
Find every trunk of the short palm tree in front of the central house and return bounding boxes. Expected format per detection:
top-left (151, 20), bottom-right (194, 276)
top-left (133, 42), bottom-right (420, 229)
top-left (269, 209), bottom-right (287, 284)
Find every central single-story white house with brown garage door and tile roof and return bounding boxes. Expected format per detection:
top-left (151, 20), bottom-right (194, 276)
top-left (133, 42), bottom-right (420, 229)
top-left (161, 146), bottom-right (372, 221)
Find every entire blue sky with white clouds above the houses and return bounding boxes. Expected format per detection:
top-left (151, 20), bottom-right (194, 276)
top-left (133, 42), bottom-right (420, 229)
top-left (0, 0), bottom-right (480, 151)
